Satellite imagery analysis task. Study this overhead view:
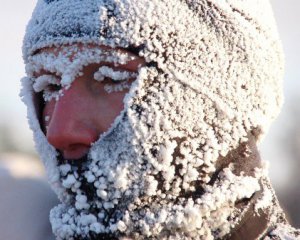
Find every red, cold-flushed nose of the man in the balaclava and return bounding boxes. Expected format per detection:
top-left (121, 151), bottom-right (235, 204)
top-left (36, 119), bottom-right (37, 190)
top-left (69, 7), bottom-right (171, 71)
top-left (43, 83), bottom-right (99, 160)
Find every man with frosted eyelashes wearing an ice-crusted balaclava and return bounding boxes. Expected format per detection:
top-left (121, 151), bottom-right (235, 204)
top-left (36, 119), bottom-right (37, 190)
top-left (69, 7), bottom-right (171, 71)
top-left (21, 0), bottom-right (300, 240)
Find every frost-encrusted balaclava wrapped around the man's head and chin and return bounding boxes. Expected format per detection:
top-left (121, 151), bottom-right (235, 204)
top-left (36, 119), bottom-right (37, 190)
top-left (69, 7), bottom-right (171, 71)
top-left (22, 0), bottom-right (283, 239)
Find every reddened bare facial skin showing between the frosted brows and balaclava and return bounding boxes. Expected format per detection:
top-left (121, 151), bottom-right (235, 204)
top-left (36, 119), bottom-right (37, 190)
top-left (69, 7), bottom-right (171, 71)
top-left (35, 45), bottom-right (144, 160)
